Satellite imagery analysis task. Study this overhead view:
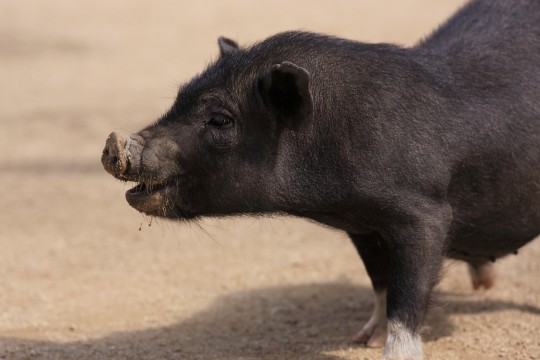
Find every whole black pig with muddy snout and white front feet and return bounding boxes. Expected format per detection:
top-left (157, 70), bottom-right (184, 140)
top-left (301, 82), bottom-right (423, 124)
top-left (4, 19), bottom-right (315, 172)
top-left (102, 0), bottom-right (540, 359)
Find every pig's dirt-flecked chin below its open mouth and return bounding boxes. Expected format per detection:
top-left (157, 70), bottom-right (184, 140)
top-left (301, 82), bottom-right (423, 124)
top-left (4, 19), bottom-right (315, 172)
top-left (126, 183), bottom-right (176, 216)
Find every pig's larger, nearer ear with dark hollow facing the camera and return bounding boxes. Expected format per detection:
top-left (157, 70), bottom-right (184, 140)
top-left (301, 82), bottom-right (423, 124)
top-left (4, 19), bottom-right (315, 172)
top-left (259, 61), bottom-right (313, 131)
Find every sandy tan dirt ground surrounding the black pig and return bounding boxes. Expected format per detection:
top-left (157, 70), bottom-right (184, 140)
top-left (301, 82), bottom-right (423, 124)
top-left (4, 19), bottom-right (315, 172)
top-left (0, 0), bottom-right (540, 360)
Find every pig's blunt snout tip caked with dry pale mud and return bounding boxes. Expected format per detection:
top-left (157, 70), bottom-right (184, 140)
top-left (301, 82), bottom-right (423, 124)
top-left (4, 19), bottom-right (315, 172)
top-left (101, 132), bottom-right (145, 180)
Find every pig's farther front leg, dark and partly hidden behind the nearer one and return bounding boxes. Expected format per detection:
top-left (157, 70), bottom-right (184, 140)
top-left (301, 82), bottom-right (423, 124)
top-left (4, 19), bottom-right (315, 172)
top-left (349, 232), bottom-right (390, 347)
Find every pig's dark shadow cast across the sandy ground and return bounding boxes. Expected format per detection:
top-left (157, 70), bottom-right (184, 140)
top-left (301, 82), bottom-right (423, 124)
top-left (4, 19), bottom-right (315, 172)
top-left (0, 283), bottom-right (540, 360)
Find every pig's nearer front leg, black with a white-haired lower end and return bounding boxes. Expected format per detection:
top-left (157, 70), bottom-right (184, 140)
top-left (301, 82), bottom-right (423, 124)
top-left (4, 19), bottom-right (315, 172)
top-left (383, 206), bottom-right (451, 360)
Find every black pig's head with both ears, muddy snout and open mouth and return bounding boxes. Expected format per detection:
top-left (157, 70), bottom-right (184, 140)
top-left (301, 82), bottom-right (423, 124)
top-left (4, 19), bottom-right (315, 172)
top-left (101, 38), bottom-right (313, 219)
